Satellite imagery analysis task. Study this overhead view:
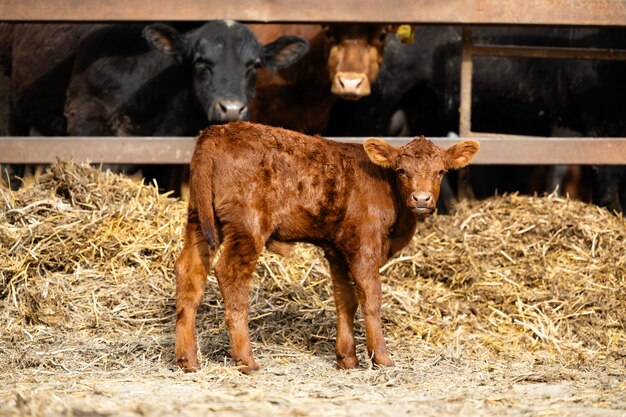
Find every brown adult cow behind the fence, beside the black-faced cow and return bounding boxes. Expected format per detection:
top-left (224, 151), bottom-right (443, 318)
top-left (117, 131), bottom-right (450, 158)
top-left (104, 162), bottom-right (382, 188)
top-left (248, 24), bottom-right (392, 134)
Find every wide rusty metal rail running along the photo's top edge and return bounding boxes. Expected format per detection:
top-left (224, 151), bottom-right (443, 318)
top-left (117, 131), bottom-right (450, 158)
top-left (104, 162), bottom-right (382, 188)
top-left (0, 0), bottom-right (626, 26)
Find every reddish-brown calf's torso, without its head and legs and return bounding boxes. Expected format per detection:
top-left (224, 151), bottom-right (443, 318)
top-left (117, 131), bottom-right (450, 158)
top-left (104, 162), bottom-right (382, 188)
top-left (191, 122), bottom-right (394, 243)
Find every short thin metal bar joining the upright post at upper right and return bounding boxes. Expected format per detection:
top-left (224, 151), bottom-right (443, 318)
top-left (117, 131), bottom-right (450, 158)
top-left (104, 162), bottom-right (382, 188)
top-left (472, 45), bottom-right (626, 61)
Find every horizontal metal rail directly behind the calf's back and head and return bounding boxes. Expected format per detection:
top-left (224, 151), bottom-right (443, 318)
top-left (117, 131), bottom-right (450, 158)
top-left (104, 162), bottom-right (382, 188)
top-left (0, 137), bottom-right (626, 165)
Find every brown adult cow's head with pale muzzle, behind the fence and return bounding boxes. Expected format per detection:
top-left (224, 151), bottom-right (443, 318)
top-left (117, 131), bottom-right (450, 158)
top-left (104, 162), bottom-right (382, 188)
top-left (324, 24), bottom-right (391, 100)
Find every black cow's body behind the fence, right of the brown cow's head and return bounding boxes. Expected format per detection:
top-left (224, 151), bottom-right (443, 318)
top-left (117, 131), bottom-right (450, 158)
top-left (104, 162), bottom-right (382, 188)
top-left (340, 26), bottom-right (626, 211)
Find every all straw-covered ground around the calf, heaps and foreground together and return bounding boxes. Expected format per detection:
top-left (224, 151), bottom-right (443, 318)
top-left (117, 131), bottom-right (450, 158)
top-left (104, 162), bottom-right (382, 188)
top-left (0, 163), bottom-right (626, 417)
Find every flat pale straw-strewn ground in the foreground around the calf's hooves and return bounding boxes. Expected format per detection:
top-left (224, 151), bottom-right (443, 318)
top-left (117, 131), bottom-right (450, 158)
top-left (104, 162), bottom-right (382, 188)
top-left (0, 343), bottom-right (626, 417)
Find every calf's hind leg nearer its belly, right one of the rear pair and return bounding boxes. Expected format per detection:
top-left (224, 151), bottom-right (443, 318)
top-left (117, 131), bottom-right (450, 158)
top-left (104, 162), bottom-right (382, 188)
top-left (215, 225), bottom-right (263, 374)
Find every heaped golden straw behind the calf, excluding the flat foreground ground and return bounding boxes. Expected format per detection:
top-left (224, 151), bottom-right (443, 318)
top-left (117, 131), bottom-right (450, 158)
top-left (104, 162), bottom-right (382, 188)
top-left (0, 161), bottom-right (626, 371)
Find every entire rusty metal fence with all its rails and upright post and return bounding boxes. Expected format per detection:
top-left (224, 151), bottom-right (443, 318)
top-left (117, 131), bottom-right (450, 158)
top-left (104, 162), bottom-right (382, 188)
top-left (0, 0), bottom-right (626, 165)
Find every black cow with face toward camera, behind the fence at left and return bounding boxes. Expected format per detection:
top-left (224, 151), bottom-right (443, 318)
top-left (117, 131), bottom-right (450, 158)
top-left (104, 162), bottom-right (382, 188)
top-left (65, 20), bottom-right (308, 136)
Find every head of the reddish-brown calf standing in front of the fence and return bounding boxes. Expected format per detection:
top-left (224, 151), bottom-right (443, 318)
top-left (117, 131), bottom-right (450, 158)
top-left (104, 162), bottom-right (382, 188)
top-left (363, 136), bottom-right (480, 217)
